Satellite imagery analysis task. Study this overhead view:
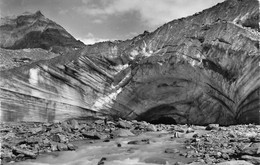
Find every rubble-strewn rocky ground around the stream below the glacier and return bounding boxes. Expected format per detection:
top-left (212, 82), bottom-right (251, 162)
top-left (0, 119), bottom-right (260, 165)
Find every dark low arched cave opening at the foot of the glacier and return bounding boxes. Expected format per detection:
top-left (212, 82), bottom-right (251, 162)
top-left (137, 104), bottom-right (177, 124)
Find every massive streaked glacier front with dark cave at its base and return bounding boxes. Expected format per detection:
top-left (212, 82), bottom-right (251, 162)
top-left (0, 0), bottom-right (260, 125)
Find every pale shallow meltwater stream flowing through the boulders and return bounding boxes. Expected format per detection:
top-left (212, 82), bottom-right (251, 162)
top-left (12, 132), bottom-right (195, 165)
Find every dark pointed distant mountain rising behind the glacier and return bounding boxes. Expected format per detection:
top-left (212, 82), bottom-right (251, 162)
top-left (0, 11), bottom-right (85, 54)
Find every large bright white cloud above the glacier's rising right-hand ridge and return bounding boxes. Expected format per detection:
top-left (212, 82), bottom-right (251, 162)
top-left (77, 0), bottom-right (224, 26)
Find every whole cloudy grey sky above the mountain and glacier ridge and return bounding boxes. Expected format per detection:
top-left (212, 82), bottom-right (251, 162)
top-left (0, 0), bottom-right (224, 44)
